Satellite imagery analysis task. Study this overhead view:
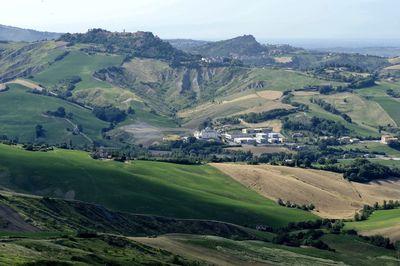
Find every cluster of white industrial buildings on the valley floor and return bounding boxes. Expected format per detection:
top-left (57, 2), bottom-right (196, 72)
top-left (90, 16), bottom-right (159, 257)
top-left (194, 127), bottom-right (285, 144)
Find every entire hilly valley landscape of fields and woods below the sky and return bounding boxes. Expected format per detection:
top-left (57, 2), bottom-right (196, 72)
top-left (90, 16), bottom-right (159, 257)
top-left (0, 18), bottom-right (400, 266)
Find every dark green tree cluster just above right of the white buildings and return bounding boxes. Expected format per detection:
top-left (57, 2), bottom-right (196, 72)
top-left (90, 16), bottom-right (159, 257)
top-left (282, 116), bottom-right (350, 137)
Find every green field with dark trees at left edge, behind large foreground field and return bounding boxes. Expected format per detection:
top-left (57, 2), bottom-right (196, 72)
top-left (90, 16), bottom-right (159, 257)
top-left (0, 84), bottom-right (108, 144)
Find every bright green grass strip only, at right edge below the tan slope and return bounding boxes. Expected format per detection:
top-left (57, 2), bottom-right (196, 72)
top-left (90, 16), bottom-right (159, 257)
top-left (345, 209), bottom-right (400, 232)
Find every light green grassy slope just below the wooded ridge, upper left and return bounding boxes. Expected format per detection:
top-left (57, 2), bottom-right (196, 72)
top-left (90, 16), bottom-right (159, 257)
top-left (33, 50), bottom-right (122, 90)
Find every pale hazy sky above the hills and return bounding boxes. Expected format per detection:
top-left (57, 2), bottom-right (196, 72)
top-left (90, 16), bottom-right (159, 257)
top-left (0, 0), bottom-right (400, 40)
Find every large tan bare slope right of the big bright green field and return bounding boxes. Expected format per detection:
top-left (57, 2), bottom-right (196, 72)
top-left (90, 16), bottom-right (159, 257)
top-left (212, 163), bottom-right (400, 218)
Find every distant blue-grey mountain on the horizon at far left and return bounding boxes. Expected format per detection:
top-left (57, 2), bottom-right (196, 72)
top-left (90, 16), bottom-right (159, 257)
top-left (0, 25), bottom-right (62, 42)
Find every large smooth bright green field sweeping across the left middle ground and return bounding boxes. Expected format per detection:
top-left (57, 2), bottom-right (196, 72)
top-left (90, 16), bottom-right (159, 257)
top-left (0, 145), bottom-right (316, 226)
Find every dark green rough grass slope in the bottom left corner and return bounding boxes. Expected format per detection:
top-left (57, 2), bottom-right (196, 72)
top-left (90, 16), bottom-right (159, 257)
top-left (0, 236), bottom-right (201, 265)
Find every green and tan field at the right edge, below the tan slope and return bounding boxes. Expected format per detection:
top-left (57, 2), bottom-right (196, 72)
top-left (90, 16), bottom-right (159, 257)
top-left (345, 209), bottom-right (400, 240)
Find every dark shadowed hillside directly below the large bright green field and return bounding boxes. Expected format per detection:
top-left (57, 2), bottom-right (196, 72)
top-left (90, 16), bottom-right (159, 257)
top-left (0, 192), bottom-right (262, 239)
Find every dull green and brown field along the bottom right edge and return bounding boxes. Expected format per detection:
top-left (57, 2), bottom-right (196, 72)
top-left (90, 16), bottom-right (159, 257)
top-left (133, 234), bottom-right (399, 266)
